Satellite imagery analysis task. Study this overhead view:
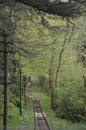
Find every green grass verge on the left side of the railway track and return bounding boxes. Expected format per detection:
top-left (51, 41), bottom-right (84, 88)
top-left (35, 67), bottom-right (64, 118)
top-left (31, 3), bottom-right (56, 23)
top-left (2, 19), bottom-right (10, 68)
top-left (9, 100), bottom-right (34, 130)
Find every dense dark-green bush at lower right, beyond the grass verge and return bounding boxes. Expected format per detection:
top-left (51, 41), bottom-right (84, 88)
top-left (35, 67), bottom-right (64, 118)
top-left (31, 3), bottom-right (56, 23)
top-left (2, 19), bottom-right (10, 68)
top-left (56, 87), bottom-right (86, 122)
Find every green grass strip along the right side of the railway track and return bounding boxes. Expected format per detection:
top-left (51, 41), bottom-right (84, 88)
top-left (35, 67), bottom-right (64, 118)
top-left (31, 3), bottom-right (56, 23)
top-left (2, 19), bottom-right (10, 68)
top-left (41, 92), bottom-right (86, 130)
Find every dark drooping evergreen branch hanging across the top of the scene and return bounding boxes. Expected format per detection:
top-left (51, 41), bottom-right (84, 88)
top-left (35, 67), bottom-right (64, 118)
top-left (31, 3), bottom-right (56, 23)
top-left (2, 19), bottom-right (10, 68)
top-left (17, 0), bottom-right (86, 17)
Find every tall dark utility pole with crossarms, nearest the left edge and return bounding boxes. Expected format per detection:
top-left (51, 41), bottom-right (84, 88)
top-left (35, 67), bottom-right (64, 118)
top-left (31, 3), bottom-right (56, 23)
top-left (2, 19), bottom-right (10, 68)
top-left (3, 35), bottom-right (8, 130)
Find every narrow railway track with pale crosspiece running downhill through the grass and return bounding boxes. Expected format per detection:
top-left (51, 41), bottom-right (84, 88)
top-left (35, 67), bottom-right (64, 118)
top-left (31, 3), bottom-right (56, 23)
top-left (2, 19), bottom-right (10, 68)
top-left (32, 98), bottom-right (50, 130)
